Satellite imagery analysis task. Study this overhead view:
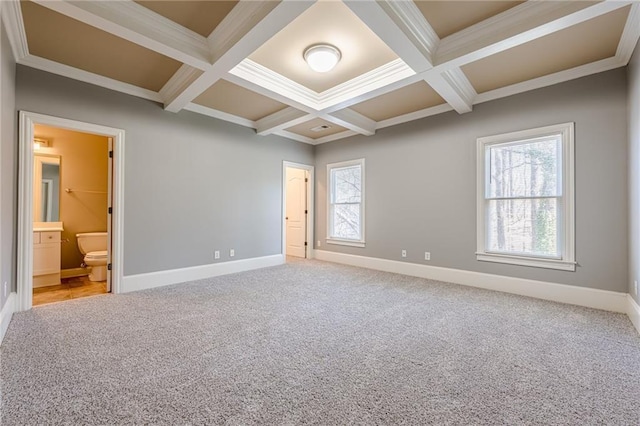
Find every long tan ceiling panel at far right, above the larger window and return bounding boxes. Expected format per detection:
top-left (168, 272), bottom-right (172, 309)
top-left (462, 7), bottom-right (629, 93)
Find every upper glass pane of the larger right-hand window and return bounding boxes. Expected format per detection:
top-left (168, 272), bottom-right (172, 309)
top-left (488, 140), bottom-right (562, 198)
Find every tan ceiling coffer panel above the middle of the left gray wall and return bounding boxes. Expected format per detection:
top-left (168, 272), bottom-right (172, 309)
top-left (193, 80), bottom-right (287, 121)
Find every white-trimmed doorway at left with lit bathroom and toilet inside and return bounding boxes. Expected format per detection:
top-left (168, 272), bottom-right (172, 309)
top-left (17, 112), bottom-right (124, 310)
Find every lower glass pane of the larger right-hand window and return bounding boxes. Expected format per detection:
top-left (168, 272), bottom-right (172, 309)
top-left (487, 198), bottom-right (560, 257)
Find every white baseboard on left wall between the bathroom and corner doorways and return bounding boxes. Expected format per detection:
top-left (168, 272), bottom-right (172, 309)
top-left (120, 254), bottom-right (284, 293)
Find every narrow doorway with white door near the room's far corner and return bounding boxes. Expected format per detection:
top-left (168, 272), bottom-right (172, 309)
top-left (282, 161), bottom-right (314, 261)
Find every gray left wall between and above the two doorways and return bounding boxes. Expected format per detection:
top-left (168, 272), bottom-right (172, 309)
top-left (16, 66), bottom-right (313, 275)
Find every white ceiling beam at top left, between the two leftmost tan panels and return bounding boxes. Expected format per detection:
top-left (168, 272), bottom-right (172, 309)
top-left (33, 0), bottom-right (211, 69)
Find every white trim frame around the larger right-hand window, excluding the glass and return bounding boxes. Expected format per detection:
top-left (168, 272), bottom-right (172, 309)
top-left (476, 123), bottom-right (576, 271)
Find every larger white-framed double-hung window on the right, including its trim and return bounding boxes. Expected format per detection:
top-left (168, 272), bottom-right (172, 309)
top-left (476, 123), bottom-right (576, 271)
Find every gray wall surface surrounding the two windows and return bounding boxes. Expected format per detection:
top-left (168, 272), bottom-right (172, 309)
top-left (316, 69), bottom-right (628, 292)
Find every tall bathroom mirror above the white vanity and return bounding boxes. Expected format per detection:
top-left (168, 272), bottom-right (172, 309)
top-left (33, 154), bottom-right (61, 222)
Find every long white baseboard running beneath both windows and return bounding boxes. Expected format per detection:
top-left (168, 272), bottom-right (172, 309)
top-left (315, 250), bottom-right (628, 313)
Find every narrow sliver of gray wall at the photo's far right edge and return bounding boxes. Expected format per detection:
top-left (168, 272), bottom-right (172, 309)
top-left (627, 47), bottom-right (640, 303)
